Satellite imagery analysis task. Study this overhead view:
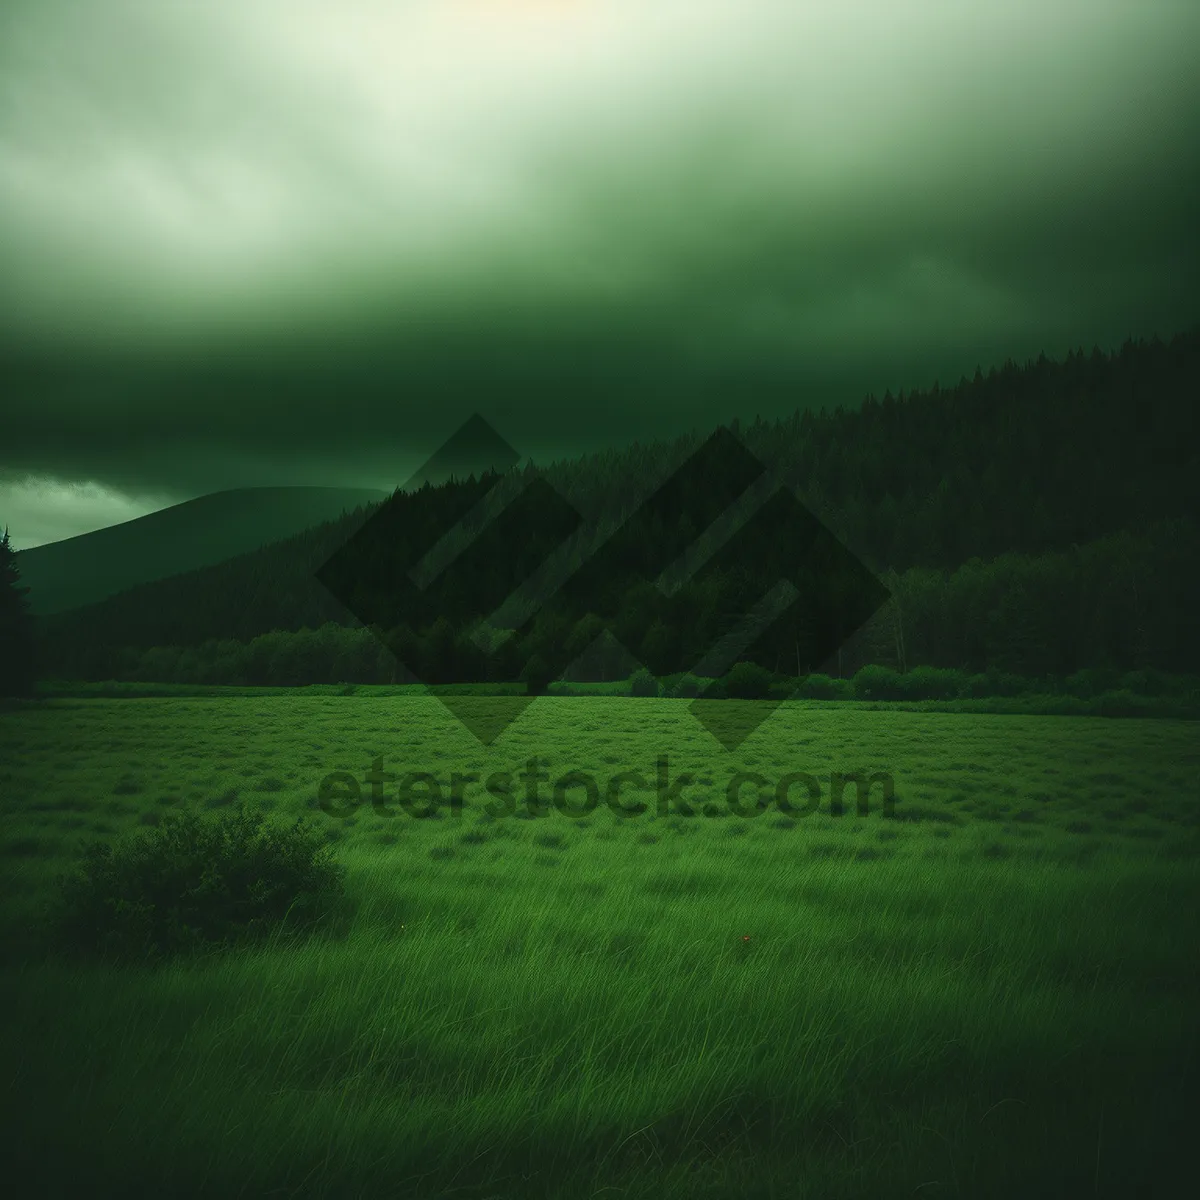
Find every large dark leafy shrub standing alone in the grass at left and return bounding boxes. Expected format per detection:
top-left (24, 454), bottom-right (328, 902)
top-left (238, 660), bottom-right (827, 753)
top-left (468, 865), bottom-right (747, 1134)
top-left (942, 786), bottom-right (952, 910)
top-left (56, 804), bottom-right (344, 961)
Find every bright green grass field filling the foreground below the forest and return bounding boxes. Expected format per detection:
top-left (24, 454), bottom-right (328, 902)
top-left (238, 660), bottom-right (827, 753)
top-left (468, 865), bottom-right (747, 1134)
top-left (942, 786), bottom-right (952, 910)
top-left (0, 694), bottom-right (1200, 1200)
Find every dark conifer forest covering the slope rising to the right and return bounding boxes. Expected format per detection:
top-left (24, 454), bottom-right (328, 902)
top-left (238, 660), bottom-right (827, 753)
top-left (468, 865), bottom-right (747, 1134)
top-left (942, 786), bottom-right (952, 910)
top-left (28, 330), bottom-right (1200, 684)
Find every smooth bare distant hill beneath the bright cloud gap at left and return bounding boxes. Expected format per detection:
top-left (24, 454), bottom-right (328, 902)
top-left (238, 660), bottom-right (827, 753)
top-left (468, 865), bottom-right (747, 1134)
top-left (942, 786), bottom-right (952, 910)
top-left (17, 487), bottom-right (389, 614)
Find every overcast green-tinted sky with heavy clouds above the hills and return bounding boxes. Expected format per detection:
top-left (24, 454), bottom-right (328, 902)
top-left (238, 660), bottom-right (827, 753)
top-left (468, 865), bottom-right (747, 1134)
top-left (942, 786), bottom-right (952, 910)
top-left (0, 0), bottom-right (1200, 547)
